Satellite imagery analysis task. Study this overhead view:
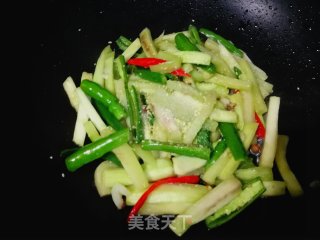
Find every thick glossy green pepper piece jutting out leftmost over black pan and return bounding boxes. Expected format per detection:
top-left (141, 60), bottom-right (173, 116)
top-left (65, 129), bottom-right (129, 172)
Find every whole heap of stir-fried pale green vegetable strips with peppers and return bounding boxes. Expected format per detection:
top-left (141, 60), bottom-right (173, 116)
top-left (63, 25), bottom-right (303, 236)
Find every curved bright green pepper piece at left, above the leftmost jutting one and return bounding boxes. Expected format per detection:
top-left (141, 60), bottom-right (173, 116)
top-left (80, 80), bottom-right (126, 119)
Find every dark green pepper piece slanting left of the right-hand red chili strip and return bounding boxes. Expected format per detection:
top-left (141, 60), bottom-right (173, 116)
top-left (219, 122), bottom-right (248, 161)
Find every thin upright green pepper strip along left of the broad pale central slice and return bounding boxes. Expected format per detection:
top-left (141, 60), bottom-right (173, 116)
top-left (129, 86), bottom-right (144, 143)
